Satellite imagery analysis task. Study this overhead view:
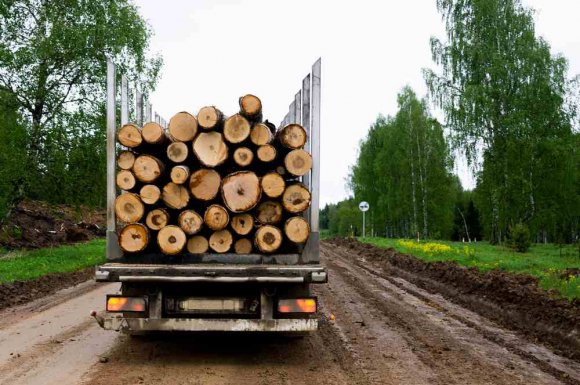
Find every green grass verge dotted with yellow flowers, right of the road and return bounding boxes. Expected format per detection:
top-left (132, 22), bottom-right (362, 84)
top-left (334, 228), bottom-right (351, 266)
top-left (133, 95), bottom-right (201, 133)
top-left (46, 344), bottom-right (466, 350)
top-left (360, 238), bottom-right (580, 300)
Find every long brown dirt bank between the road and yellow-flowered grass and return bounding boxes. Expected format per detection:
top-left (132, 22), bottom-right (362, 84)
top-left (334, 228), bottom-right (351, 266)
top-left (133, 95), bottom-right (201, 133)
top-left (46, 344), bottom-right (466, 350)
top-left (329, 239), bottom-right (580, 359)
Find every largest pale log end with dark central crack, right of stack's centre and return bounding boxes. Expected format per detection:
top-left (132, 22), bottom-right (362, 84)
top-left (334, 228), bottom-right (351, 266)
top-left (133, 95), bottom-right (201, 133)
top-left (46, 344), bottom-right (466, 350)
top-left (221, 171), bottom-right (262, 213)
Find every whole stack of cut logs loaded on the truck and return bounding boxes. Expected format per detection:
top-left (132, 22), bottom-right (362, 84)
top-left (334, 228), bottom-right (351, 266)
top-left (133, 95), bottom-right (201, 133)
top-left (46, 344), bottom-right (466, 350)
top-left (115, 95), bottom-right (312, 255)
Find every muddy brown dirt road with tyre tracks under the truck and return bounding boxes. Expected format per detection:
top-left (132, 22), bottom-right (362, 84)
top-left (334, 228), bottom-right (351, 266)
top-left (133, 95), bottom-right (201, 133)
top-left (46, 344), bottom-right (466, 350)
top-left (0, 244), bottom-right (580, 385)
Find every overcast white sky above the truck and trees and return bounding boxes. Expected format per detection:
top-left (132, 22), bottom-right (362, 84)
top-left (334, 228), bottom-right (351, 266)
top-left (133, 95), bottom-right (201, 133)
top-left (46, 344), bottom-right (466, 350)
top-left (135, 0), bottom-right (580, 205)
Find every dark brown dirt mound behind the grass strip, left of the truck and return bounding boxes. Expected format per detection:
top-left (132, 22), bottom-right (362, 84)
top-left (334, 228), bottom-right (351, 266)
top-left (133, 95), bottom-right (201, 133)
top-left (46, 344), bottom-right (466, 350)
top-left (0, 200), bottom-right (106, 249)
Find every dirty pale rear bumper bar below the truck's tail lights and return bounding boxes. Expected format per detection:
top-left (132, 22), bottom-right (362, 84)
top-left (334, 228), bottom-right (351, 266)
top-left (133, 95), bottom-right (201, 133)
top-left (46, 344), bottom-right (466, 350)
top-left (102, 316), bottom-right (318, 333)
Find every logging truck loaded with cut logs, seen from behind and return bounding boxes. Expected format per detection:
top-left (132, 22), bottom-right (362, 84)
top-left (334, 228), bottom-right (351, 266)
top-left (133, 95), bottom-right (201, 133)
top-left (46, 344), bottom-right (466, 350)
top-left (92, 59), bottom-right (327, 334)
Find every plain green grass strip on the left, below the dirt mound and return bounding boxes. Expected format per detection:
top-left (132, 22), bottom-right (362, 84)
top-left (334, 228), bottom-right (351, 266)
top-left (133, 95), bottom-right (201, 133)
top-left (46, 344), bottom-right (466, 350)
top-left (0, 239), bottom-right (105, 284)
